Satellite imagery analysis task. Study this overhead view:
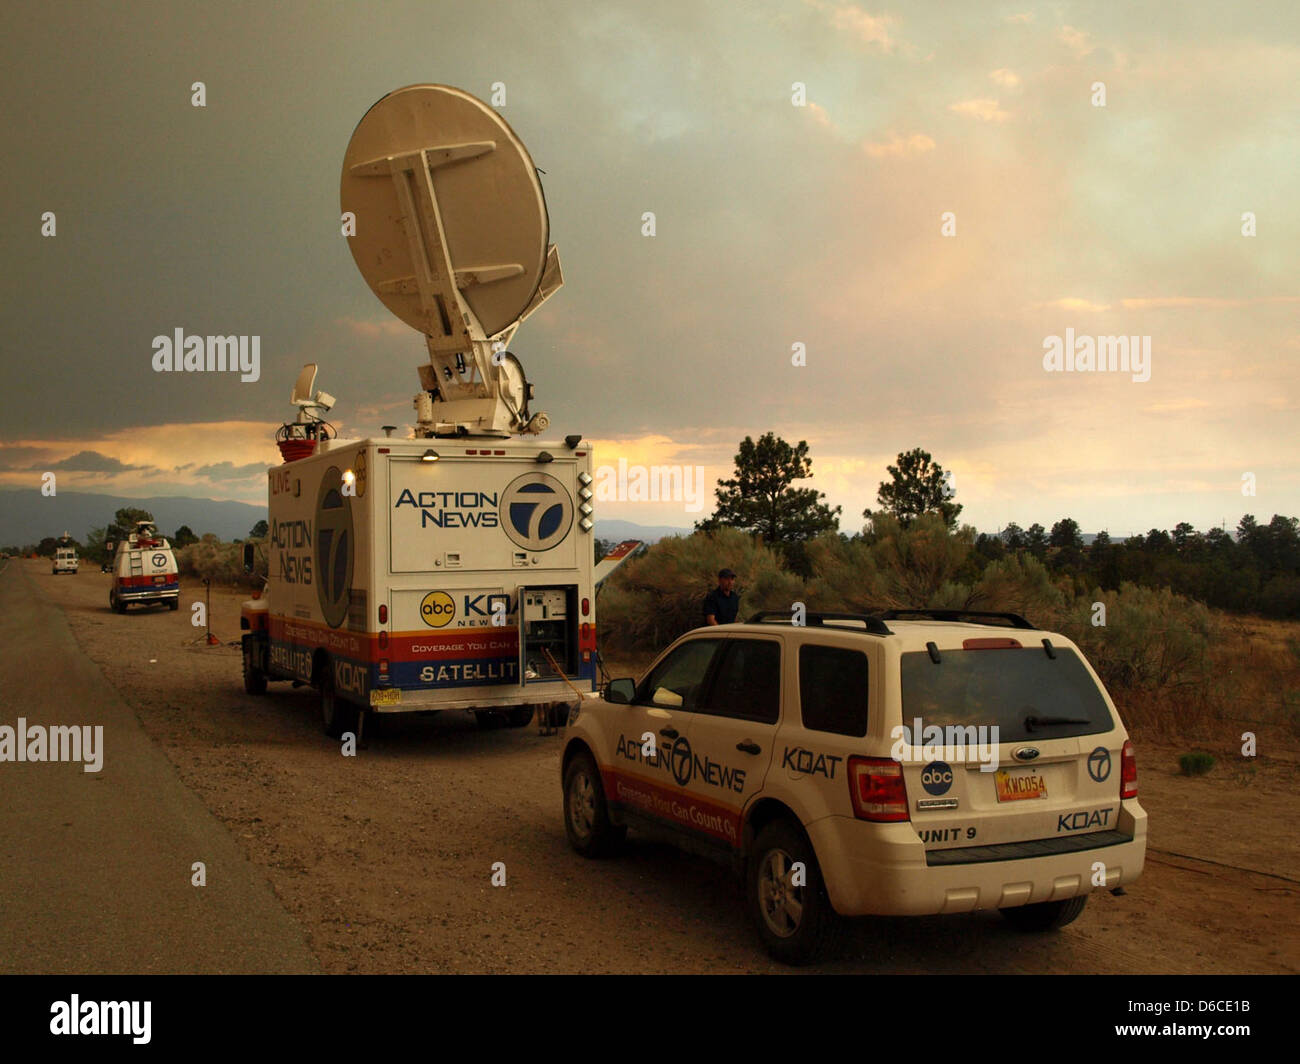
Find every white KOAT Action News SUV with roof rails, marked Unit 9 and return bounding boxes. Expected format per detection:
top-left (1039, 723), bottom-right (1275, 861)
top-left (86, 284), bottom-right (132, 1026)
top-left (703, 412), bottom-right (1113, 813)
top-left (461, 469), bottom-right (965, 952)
top-left (562, 610), bottom-right (1147, 964)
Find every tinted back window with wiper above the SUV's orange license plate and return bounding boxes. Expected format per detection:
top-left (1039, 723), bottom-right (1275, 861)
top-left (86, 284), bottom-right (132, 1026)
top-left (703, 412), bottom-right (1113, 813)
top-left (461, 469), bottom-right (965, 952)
top-left (900, 646), bottom-right (1114, 743)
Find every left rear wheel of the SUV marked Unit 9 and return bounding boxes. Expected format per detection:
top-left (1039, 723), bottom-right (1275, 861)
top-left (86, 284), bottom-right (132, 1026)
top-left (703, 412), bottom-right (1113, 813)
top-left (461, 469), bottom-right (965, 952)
top-left (745, 819), bottom-right (835, 964)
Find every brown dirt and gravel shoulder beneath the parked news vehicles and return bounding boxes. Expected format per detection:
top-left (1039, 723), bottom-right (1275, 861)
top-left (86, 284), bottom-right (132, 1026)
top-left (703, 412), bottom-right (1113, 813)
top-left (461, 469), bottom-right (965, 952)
top-left (22, 561), bottom-right (1300, 973)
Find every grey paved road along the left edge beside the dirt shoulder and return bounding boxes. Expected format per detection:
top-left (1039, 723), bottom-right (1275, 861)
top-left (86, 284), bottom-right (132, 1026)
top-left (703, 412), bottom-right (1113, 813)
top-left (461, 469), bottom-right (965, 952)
top-left (0, 562), bottom-right (320, 974)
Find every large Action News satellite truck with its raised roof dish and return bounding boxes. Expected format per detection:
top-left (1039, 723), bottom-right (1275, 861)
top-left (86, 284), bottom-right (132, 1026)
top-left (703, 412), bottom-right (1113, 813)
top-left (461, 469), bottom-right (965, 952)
top-left (241, 85), bottom-right (628, 738)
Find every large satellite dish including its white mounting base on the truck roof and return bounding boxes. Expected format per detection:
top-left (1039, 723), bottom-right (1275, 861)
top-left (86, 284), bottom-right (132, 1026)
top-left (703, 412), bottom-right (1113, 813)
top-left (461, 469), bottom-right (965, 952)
top-left (338, 78), bottom-right (564, 437)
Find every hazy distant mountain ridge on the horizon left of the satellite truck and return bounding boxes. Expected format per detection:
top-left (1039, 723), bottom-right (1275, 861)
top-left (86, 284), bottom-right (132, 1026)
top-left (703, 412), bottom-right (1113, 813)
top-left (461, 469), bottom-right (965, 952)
top-left (0, 489), bottom-right (267, 546)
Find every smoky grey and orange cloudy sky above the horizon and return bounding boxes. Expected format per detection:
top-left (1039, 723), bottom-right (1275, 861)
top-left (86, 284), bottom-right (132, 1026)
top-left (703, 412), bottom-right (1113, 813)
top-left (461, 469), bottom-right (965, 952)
top-left (0, 0), bottom-right (1300, 535)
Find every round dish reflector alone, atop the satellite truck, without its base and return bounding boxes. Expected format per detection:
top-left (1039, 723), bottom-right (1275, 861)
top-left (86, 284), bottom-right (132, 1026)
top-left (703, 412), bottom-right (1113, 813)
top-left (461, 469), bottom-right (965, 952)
top-left (341, 85), bottom-right (550, 340)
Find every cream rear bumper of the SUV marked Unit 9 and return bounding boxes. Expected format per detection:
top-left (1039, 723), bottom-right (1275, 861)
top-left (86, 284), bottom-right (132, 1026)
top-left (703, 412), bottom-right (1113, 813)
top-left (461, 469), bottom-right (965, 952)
top-left (805, 799), bottom-right (1147, 916)
